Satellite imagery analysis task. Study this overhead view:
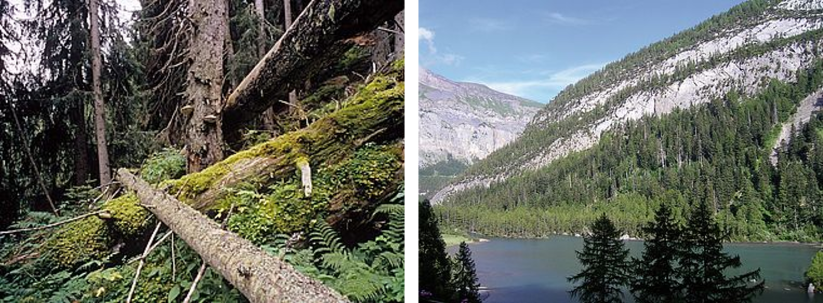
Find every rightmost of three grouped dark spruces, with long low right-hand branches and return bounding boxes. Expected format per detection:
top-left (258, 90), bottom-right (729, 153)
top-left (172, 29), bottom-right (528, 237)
top-left (679, 200), bottom-right (763, 303)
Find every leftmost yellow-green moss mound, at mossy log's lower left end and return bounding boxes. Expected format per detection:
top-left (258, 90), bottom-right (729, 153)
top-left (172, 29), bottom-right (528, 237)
top-left (45, 217), bottom-right (110, 267)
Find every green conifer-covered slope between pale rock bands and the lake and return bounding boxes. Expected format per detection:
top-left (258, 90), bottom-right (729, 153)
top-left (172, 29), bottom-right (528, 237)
top-left (436, 60), bottom-right (823, 241)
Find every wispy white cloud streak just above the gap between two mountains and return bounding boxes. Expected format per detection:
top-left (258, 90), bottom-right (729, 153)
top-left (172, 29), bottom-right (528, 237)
top-left (466, 63), bottom-right (606, 101)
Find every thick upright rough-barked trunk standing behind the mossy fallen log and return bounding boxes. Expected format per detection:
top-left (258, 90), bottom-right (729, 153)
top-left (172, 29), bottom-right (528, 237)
top-left (186, 0), bottom-right (227, 172)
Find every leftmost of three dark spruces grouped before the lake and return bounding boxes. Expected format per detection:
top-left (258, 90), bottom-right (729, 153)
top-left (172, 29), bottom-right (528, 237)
top-left (569, 213), bottom-right (629, 303)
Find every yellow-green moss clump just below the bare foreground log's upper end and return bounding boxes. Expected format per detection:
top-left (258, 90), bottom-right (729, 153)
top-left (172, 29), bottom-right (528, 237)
top-left (103, 193), bottom-right (149, 237)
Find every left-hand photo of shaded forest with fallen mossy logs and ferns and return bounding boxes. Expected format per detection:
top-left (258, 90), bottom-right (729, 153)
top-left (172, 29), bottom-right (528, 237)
top-left (0, 0), bottom-right (405, 302)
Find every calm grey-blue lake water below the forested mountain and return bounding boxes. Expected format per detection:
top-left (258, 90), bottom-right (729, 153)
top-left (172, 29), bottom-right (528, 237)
top-left (448, 236), bottom-right (823, 303)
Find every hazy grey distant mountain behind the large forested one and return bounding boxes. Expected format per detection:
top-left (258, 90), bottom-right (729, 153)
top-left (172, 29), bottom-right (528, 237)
top-left (417, 66), bottom-right (542, 195)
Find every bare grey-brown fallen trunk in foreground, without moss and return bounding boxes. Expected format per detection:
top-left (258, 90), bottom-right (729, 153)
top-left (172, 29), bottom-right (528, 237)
top-left (117, 168), bottom-right (348, 302)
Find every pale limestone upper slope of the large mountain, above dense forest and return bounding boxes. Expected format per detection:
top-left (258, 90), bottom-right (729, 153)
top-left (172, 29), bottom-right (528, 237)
top-left (432, 0), bottom-right (823, 203)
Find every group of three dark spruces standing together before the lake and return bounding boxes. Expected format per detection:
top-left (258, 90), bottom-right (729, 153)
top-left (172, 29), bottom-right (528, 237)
top-left (569, 201), bottom-right (764, 303)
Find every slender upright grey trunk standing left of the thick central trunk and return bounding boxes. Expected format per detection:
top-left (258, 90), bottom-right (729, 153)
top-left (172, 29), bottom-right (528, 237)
top-left (89, 0), bottom-right (111, 192)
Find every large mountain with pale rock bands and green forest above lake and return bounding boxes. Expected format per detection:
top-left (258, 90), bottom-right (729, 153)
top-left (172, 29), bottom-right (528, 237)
top-left (432, 0), bottom-right (823, 241)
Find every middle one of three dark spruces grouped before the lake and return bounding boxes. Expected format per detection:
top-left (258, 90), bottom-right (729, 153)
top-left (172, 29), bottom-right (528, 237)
top-left (631, 203), bottom-right (682, 303)
